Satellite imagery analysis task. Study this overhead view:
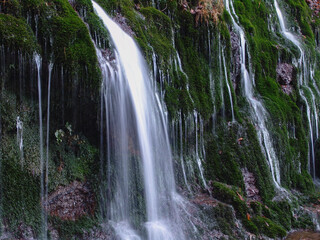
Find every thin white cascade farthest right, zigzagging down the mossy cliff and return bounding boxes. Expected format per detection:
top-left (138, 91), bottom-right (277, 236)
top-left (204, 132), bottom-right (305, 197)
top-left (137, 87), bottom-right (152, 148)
top-left (274, 0), bottom-right (320, 178)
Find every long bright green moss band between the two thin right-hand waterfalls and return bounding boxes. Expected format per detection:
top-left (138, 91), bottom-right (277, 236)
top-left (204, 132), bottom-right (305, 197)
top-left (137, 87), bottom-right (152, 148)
top-left (230, 0), bottom-right (312, 192)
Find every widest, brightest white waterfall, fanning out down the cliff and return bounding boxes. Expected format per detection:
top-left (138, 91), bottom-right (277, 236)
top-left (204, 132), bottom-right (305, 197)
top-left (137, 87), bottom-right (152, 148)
top-left (93, 1), bottom-right (185, 240)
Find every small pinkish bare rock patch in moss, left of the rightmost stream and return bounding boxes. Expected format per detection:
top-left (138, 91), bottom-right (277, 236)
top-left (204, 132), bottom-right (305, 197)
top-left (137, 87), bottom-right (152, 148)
top-left (277, 63), bottom-right (293, 95)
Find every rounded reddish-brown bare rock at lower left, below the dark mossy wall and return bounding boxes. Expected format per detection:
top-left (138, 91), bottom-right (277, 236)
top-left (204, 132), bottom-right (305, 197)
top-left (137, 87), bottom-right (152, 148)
top-left (46, 181), bottom-right (96, 221)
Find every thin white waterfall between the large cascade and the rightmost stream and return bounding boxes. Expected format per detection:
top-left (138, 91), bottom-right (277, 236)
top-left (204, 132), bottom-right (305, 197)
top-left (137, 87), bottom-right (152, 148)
top-left (226, 0), bottom-right (283, 190)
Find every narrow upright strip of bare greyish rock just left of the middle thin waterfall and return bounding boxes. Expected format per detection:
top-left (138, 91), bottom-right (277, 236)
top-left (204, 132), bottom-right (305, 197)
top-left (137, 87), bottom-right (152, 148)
top-left (230, 31), bottom-right (241, 90)
